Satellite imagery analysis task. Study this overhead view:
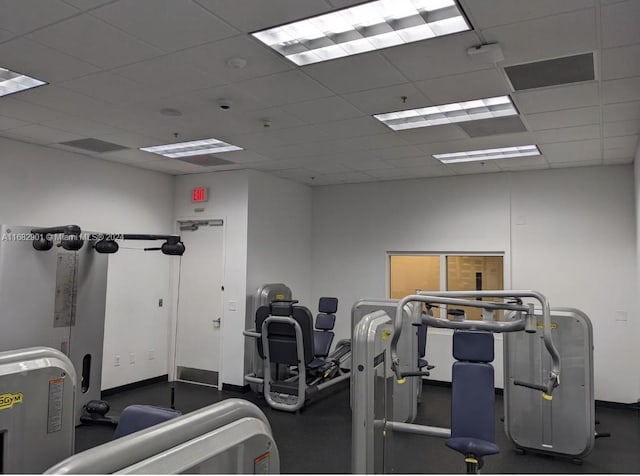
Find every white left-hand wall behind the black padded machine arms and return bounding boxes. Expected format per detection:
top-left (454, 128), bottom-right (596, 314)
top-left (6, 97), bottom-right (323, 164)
top-left (0, 138), bottom-right (173, 389)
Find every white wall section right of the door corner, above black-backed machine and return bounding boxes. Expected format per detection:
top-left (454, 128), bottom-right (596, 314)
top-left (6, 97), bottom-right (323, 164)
top-left (245, 171), bottom-right (317, 376)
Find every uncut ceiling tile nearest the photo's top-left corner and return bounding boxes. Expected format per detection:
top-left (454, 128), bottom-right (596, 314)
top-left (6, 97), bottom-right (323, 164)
top-left (29, 14), bottom-right (161, 68)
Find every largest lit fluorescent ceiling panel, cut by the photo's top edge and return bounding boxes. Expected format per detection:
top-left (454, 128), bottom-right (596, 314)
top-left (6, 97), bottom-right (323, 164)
top-left (252, 0), bottom-right (471, 66)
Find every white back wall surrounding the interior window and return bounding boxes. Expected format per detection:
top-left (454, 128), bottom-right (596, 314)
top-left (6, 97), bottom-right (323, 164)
top-left (312, 166), bottom-right (639, 402)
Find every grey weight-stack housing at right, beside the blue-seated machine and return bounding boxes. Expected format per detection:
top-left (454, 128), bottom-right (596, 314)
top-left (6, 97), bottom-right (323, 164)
top-left (503, 308), bottom-right (609, 463)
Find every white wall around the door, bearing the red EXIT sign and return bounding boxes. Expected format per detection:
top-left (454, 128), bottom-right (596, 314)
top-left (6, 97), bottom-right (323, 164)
top-left (175, 171), bottom-right (249, 386)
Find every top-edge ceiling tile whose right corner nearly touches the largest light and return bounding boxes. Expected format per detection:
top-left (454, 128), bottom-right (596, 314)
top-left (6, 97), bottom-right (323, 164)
top-left (91, 0), bottom-right (239, 51)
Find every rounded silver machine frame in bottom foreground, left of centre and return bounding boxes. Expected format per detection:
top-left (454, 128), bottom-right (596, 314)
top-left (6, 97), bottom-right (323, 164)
top-left (45, 398), bottom-right (280, 474)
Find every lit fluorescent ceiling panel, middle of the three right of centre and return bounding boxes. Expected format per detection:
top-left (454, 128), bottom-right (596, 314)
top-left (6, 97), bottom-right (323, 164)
top-left (373, 96), bottom-right (518, 131)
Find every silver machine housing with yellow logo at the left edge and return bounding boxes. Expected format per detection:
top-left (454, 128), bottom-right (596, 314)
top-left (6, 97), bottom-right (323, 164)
top-left (0, 347), bottom-right (77, 474)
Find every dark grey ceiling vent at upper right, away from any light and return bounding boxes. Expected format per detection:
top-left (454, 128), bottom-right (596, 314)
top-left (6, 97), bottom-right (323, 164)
top-left (504, 53), bottom-right (595, 91)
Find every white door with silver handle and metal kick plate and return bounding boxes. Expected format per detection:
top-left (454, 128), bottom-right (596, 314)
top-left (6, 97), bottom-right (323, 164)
top-left (175, 220), bottom-right (224, 386)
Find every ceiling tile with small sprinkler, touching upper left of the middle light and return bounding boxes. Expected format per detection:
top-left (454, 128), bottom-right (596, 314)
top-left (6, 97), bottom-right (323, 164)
top-left (342, 83), bottom-right (431, 115)
